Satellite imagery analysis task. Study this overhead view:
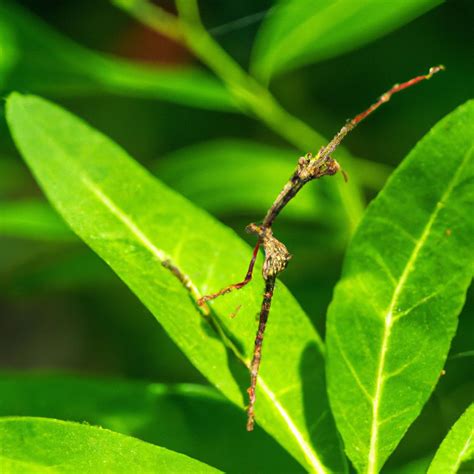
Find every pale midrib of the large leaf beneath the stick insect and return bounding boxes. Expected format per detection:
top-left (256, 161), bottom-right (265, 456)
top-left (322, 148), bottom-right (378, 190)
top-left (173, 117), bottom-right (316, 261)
top-left (17, 100), bottom-right (328, 474)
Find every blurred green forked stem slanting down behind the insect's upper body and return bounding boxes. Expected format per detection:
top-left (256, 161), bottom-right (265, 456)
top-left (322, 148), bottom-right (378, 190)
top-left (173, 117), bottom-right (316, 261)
top-left (112, 0), bottom-right (364, 231)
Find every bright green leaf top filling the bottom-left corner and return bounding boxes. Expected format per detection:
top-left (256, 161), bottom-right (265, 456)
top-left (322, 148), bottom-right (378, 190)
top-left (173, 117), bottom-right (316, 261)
top-left (0, 417), bottom-right (220, 474)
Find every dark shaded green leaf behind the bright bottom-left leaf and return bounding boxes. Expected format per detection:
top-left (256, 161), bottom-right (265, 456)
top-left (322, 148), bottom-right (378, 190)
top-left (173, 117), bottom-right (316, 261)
top-left (0, 375), bottom-right (301, 473)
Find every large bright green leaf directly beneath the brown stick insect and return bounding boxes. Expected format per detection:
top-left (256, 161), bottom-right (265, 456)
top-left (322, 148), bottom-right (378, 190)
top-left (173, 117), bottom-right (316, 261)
top-left (7, 94), bottom-right (345, 472)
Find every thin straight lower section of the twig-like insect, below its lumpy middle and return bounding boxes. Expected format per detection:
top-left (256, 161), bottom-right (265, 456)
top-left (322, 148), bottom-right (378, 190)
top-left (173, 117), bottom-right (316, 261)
top-left (247, 277), bottom-right (276, 431)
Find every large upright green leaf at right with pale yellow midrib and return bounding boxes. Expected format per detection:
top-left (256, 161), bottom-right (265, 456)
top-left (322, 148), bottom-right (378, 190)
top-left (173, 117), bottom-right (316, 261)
top-left (327, 101), bottom-right (474, 473)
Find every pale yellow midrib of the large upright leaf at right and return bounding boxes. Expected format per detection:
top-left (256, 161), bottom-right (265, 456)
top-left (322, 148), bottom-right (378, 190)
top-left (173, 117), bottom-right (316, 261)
top-left (367, 147), bottom-right (474, 474)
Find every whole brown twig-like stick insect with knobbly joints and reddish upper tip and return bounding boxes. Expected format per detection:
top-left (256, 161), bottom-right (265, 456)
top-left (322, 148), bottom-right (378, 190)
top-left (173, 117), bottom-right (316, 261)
top-left (198, 66), bottom-right (444, 431)
